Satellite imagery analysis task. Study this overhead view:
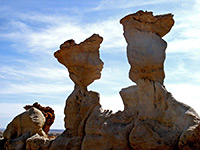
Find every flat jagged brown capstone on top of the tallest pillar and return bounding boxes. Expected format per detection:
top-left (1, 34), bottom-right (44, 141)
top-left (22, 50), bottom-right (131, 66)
top-left (120, 10), bottom-right (174, 37)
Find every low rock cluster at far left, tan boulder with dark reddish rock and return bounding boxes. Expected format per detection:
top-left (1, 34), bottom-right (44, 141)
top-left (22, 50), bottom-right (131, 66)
top-left (1, 103), bottom-right (55, 150)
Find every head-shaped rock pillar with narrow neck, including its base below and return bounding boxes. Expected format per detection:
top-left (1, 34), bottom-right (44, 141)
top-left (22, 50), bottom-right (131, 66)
top-left (50, 34), bottom-right (103, 150)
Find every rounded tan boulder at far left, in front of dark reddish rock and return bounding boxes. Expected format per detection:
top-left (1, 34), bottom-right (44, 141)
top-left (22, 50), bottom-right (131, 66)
top-left (3, 107), bottom-right (47, 150)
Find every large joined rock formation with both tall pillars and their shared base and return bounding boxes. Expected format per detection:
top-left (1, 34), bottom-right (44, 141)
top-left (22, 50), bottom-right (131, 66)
top-left (50, 11), bottom-right (200, 150)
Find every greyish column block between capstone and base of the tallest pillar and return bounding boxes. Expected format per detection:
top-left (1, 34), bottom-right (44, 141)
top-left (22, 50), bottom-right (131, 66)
top-left (124, 29), bottom-right (167, 83)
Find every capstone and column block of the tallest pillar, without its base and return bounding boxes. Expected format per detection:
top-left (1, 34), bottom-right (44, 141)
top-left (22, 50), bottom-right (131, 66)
top-left (120, 11), bottom-right (174, 83)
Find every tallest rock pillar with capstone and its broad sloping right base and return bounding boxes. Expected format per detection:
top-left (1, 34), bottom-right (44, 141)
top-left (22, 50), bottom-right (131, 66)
top-left (120, 11), bottom-right (200, 150)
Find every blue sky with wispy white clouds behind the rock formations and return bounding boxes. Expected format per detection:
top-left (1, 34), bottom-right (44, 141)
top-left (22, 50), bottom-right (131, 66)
top-left (0, 0), bottom-right (200, 129)
